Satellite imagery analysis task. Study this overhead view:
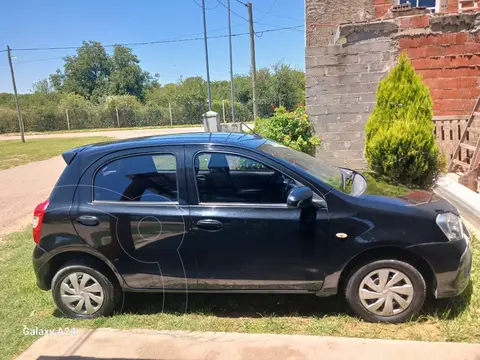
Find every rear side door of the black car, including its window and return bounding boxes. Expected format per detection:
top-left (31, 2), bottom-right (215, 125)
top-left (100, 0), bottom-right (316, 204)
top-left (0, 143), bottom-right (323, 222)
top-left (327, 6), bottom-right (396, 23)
top-left (71, 146), bottom-right (197, 290)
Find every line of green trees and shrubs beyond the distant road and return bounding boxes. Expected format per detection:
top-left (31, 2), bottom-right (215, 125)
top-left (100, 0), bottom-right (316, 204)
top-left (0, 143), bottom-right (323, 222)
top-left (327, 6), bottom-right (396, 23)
top-left (0, 41), bottom-right (305, 133)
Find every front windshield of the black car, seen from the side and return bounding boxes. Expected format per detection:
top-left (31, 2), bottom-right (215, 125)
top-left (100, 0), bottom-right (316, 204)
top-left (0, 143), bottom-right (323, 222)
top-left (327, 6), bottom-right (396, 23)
top-left (258, 140), bottom-right (351, 194)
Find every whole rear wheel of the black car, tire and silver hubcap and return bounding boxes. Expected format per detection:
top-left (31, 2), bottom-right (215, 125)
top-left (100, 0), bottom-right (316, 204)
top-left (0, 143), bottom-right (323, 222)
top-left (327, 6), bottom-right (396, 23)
top-left (52, 263), bottom-right (121, 319)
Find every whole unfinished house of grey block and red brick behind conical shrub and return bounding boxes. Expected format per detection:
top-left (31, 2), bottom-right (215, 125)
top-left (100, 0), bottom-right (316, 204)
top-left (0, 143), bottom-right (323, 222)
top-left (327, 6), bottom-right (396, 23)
top-left (306, 0), bottom-right (480, 180)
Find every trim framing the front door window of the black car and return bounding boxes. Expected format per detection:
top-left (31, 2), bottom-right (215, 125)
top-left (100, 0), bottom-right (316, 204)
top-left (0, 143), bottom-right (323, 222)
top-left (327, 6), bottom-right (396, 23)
top-left (190, 150), bottom-right (315, 205)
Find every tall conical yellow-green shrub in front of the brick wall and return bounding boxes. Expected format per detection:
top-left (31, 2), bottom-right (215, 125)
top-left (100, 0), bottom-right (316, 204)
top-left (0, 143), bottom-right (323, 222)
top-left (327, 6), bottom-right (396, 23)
top-left (365, 55), bottom-right (445, 187)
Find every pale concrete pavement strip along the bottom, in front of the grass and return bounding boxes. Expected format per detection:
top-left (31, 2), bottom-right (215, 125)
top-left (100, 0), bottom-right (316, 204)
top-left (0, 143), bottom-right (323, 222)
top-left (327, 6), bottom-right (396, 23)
top-left (17, 329), bottom-right (480, 360)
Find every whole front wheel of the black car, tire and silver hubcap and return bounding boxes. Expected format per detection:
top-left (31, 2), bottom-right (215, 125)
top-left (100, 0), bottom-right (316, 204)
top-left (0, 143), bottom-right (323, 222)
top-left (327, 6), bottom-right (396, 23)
top-left (345, 260), bottom-right (426, 324)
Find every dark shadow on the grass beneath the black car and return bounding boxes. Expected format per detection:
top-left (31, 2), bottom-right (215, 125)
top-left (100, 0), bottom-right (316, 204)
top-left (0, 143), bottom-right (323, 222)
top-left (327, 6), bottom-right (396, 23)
top-left (103, 282), bottom-right (473, 319)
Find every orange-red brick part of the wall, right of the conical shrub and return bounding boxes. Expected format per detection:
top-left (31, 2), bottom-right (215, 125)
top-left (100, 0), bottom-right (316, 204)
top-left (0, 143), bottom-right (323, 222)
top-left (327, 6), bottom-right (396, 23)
top-left (399, 14), bottom-right (480, 116)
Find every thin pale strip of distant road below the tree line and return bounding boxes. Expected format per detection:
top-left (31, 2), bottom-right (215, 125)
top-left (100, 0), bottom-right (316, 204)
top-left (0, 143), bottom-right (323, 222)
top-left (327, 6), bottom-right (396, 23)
top-left (0, 127), bottom-right (204, 140)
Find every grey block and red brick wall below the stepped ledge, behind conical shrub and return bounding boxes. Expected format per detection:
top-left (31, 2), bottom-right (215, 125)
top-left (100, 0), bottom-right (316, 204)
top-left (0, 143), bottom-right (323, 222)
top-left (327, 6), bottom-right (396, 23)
top-left (306, 13), bottom-right (480, 168)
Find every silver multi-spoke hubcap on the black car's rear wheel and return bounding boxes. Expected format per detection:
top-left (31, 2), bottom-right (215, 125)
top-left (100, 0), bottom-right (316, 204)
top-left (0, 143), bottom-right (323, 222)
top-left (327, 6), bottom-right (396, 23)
top-left (60, 272), bottom-right (104, 315)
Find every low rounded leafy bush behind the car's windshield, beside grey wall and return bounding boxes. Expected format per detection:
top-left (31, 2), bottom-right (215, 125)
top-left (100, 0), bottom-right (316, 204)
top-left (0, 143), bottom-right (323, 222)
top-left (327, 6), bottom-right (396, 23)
top-left (255, 106), bottom-right (321, 155)
